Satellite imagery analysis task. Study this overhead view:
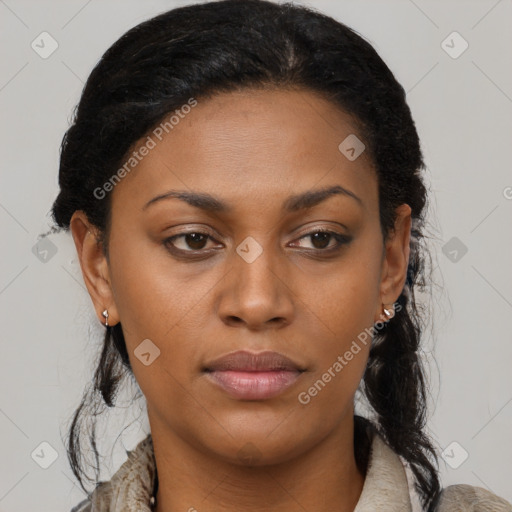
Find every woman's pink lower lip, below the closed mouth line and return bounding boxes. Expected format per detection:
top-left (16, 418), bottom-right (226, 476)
top-left (206, 370), bottom-right (301, 400)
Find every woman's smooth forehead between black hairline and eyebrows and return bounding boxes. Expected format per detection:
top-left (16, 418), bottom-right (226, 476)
top-left (113, 89), bottom-right (376, 215)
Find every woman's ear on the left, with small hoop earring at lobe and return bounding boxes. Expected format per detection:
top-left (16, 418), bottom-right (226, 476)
top-left (70, 210), bottom-right (119, 326)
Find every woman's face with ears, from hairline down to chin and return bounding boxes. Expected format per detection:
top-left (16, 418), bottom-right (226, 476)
top-left (72, 90), bottom-right (410, 463)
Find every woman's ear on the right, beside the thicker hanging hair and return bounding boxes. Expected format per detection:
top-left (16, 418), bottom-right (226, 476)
top-left (375, 203), bottom-right (412, 322)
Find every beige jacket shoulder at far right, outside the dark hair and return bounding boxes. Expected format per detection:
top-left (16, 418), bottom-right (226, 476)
top-left (436, 484), bottom-right (512, 512)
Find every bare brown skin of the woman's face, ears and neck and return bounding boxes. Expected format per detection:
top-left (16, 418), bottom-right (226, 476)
top-left (71, 89), bottom-right (411, 512)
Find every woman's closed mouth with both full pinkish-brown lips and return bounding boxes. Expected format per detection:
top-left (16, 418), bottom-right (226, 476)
top-left (203, 351), bottom-right (305, 400)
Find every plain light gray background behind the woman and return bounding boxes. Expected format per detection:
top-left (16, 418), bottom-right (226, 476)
top-left (0, 0), bottom-right (512, 512)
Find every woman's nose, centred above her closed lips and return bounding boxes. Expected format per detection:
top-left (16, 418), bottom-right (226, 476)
top-left (218, 241), bottom-right (295, 331)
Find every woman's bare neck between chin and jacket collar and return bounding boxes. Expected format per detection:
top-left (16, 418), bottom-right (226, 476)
top-left (150, 415), bottom-right (364, 512)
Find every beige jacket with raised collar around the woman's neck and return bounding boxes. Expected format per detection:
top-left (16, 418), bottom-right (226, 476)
top-left (71, 434), bottom-right (512, 512)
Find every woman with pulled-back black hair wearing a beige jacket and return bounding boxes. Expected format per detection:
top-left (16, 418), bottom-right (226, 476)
top-left (47, 0), bottom-right (512, 512)
